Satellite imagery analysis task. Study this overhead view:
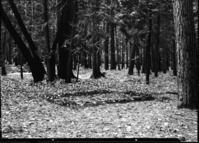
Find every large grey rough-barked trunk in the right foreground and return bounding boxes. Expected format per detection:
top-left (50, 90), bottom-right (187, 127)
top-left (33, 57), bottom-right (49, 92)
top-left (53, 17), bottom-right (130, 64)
top-left (173, 0), bottom-right (199, 109)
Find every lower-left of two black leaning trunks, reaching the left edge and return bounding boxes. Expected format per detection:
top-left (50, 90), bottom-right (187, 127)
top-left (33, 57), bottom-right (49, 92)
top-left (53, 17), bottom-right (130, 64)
top-left (0, 6), bottom-right (44, 82)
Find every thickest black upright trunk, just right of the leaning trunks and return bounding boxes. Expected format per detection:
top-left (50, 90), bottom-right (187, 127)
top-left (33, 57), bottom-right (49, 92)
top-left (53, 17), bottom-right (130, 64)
top-left (58, 0), bottom-right (75, 81)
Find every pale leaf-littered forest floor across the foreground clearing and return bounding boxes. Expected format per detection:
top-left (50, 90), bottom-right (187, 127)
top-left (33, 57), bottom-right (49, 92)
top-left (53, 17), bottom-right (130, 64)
top-left (1, 66), bottom-right (198, 142)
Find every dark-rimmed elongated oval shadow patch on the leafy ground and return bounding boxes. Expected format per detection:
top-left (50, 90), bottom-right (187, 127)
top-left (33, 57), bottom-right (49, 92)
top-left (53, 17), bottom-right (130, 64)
top-left (45, 90), bottom-right (155, 109)
